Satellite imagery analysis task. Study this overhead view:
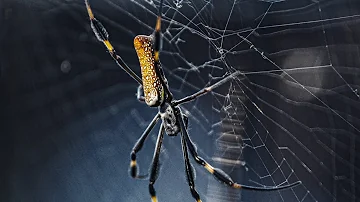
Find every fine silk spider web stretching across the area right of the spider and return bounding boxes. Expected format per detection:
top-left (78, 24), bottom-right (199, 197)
top-left (119, 0), bottom-right (360, 201)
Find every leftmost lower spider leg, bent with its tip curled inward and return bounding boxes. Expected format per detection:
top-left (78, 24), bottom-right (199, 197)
top-left (130, 113), bottom-right (160, 179)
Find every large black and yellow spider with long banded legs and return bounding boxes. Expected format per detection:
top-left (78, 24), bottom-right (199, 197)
top-left (85, 0), bottom-right (301, 202)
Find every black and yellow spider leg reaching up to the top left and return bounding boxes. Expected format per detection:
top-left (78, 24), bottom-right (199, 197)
top-left (85, 0), bottom-right (142, 85)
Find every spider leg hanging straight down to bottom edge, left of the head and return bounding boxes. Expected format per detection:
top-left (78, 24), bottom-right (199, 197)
top-left (149, 124), bottom-right (164, 202)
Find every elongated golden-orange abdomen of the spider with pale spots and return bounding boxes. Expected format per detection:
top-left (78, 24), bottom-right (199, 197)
top-left (134, 35), bottom-right (164, 107)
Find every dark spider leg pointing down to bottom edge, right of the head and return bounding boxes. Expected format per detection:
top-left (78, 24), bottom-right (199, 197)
top-left (178, 118), bottom-right (201, 202)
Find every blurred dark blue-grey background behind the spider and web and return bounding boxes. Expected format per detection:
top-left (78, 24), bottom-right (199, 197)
top-left (0, 0), bottom-right (360, 202)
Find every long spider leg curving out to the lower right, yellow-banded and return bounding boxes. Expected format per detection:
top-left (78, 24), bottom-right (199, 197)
top-left (177, 108), bottom-right (301, 191)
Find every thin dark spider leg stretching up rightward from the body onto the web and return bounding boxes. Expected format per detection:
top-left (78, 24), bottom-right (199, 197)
top-left (173, 71), bottom-right (242, 106)
